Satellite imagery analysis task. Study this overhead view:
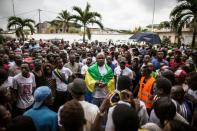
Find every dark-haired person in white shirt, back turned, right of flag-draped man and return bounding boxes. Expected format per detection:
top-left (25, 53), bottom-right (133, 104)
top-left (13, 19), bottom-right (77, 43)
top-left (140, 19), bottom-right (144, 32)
top-left (105, 76), bottom-right (148, 131)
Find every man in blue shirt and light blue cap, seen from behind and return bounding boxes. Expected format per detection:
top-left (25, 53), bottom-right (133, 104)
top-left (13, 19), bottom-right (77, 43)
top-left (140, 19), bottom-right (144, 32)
top-left (23, 86), bottom-right (57, 131)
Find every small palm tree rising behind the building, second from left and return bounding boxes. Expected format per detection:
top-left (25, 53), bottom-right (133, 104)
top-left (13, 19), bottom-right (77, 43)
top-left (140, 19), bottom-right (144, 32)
top-left (54, 10), bottom-right (72, 32)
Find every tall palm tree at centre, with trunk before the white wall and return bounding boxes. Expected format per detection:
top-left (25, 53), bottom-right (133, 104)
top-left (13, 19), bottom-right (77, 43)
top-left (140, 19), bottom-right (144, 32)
top-left (72, 3), bottom-right (103, 42)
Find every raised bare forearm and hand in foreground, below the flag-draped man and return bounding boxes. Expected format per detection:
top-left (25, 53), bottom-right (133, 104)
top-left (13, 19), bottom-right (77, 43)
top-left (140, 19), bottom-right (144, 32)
top-left (99, 94), bottom-right (113, 113)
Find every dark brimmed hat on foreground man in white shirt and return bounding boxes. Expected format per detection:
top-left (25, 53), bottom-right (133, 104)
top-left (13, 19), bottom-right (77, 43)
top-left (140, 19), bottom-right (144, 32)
top-left (68, 78), bottom-right (87, 95)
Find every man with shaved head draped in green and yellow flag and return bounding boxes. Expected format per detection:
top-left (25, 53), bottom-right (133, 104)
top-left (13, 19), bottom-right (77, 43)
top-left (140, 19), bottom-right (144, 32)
top-left (85, 52), bottom-right (115, 106)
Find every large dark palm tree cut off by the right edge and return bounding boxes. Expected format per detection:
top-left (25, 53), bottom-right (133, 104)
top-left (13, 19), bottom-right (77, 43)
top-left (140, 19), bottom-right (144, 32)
top-left (170, 0), bottom-right (197, 47)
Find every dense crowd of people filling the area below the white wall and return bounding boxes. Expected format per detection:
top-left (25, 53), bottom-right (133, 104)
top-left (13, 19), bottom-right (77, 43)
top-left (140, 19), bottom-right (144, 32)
top-left (0, 39), bottom-right (197, 131)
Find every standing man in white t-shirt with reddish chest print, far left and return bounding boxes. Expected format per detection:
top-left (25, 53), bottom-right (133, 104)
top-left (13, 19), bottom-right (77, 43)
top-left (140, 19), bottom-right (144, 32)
top-left (13, 63), bottom-right (36, 115)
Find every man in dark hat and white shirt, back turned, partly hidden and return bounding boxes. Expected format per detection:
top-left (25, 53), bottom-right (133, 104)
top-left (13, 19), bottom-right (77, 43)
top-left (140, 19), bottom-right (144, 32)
top-left (58, 78), bottom-right (100, 131)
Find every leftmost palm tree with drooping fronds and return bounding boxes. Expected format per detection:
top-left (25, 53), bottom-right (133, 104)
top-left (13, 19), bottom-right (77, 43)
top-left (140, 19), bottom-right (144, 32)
top-left (7, 16), bottom-right (35, 41)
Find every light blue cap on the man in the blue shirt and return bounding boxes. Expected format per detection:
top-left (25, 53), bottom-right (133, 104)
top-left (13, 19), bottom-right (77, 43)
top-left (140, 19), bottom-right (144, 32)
top-left (33, 86), bottom-right (51, 108)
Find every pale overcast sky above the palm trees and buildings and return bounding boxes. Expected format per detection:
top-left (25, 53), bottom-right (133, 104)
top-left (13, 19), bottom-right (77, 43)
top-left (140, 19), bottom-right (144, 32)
top-left (0, 0), bottom-right (176, 29)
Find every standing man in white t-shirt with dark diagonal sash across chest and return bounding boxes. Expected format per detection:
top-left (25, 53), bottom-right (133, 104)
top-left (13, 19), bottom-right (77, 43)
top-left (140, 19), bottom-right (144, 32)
top-left (53, 58), bottom-right (73, 110)
